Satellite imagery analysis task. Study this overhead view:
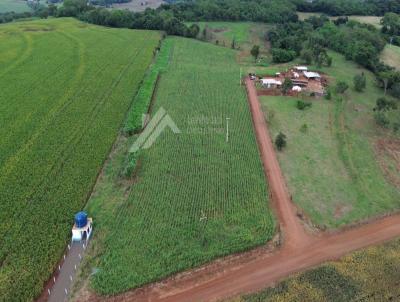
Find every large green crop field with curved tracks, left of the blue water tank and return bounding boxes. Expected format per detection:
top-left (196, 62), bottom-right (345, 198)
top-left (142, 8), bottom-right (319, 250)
top-left (0, 19), bottom-right (160, 301)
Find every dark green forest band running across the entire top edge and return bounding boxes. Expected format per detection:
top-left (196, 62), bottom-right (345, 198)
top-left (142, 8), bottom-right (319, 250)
top-left (0, 0), bottom-right (400, 26)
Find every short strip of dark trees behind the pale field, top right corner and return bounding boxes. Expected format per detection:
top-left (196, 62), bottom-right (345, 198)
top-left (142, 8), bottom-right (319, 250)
top-left (292, 0), bottom-right (400, 16)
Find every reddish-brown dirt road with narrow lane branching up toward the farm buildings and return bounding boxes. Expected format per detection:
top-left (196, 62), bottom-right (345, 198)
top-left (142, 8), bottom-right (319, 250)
top-left (89, 79), bottom-right (400, 302)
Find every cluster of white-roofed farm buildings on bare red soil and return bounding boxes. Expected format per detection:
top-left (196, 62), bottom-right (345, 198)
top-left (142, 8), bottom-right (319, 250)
top-left (260, 66), bottom-right (326, 96)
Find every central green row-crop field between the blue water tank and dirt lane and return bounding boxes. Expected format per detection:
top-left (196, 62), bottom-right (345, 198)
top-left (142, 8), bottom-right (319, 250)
top-left (80, 38), bottom-right (274, 294)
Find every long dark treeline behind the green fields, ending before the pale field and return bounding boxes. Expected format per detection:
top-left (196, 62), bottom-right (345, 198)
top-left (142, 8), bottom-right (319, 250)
top-left (0, 0), bottom-right (298, 37)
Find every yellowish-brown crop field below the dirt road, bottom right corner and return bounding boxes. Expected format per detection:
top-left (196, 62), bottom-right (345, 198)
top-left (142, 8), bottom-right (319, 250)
top-left (236, 240), bottom-right (400, 302)
